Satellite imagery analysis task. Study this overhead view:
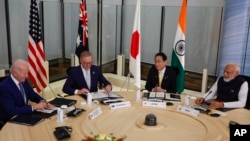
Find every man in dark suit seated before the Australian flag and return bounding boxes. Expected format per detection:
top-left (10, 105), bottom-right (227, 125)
top-left (63, 51), bottom-right (112, 95)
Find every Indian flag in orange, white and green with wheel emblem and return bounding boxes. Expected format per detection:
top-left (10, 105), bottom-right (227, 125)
top-left (171, 0), bottom-right (187, 93)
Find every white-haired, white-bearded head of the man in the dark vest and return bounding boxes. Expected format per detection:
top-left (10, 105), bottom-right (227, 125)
top-left (224, 63), bottom-right (240, 82)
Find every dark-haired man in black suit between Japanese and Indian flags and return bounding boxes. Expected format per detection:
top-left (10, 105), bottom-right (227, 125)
top-left (145, 52), bottom-right (176, 93)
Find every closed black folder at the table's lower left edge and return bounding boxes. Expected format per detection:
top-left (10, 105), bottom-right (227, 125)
top-left (8, 115), bottom-right (44, 126)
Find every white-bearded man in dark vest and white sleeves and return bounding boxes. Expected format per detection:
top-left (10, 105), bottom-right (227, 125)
top-left (195, 63), bottom-right (248, 109)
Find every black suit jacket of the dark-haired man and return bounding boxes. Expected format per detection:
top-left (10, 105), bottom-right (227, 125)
top-left (145, 66), bottom-right (176, 93)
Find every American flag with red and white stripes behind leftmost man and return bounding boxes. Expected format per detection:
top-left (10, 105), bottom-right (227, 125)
top-left (28, 0), bottom-right (47, 92)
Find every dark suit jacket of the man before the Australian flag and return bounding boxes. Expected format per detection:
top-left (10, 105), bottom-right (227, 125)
top-left (63, 65), bottom-right (111, 95)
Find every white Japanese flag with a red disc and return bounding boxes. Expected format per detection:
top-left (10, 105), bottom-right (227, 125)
top-left (129, 0), bottom-right (141, 89)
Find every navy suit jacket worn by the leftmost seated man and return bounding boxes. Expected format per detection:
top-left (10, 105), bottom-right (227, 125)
top-left (0, 76), bottom-right (44, 122)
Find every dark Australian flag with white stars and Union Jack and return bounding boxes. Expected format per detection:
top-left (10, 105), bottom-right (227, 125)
top-left (75, 0), bottom-right (89, 57)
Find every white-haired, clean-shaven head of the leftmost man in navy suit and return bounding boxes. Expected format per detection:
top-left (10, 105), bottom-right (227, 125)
top-left (10, 59), bottom-right (29, 82)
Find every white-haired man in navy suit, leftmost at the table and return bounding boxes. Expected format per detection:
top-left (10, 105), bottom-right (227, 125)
top-left (0, 59), bottom-right (54, 129)
